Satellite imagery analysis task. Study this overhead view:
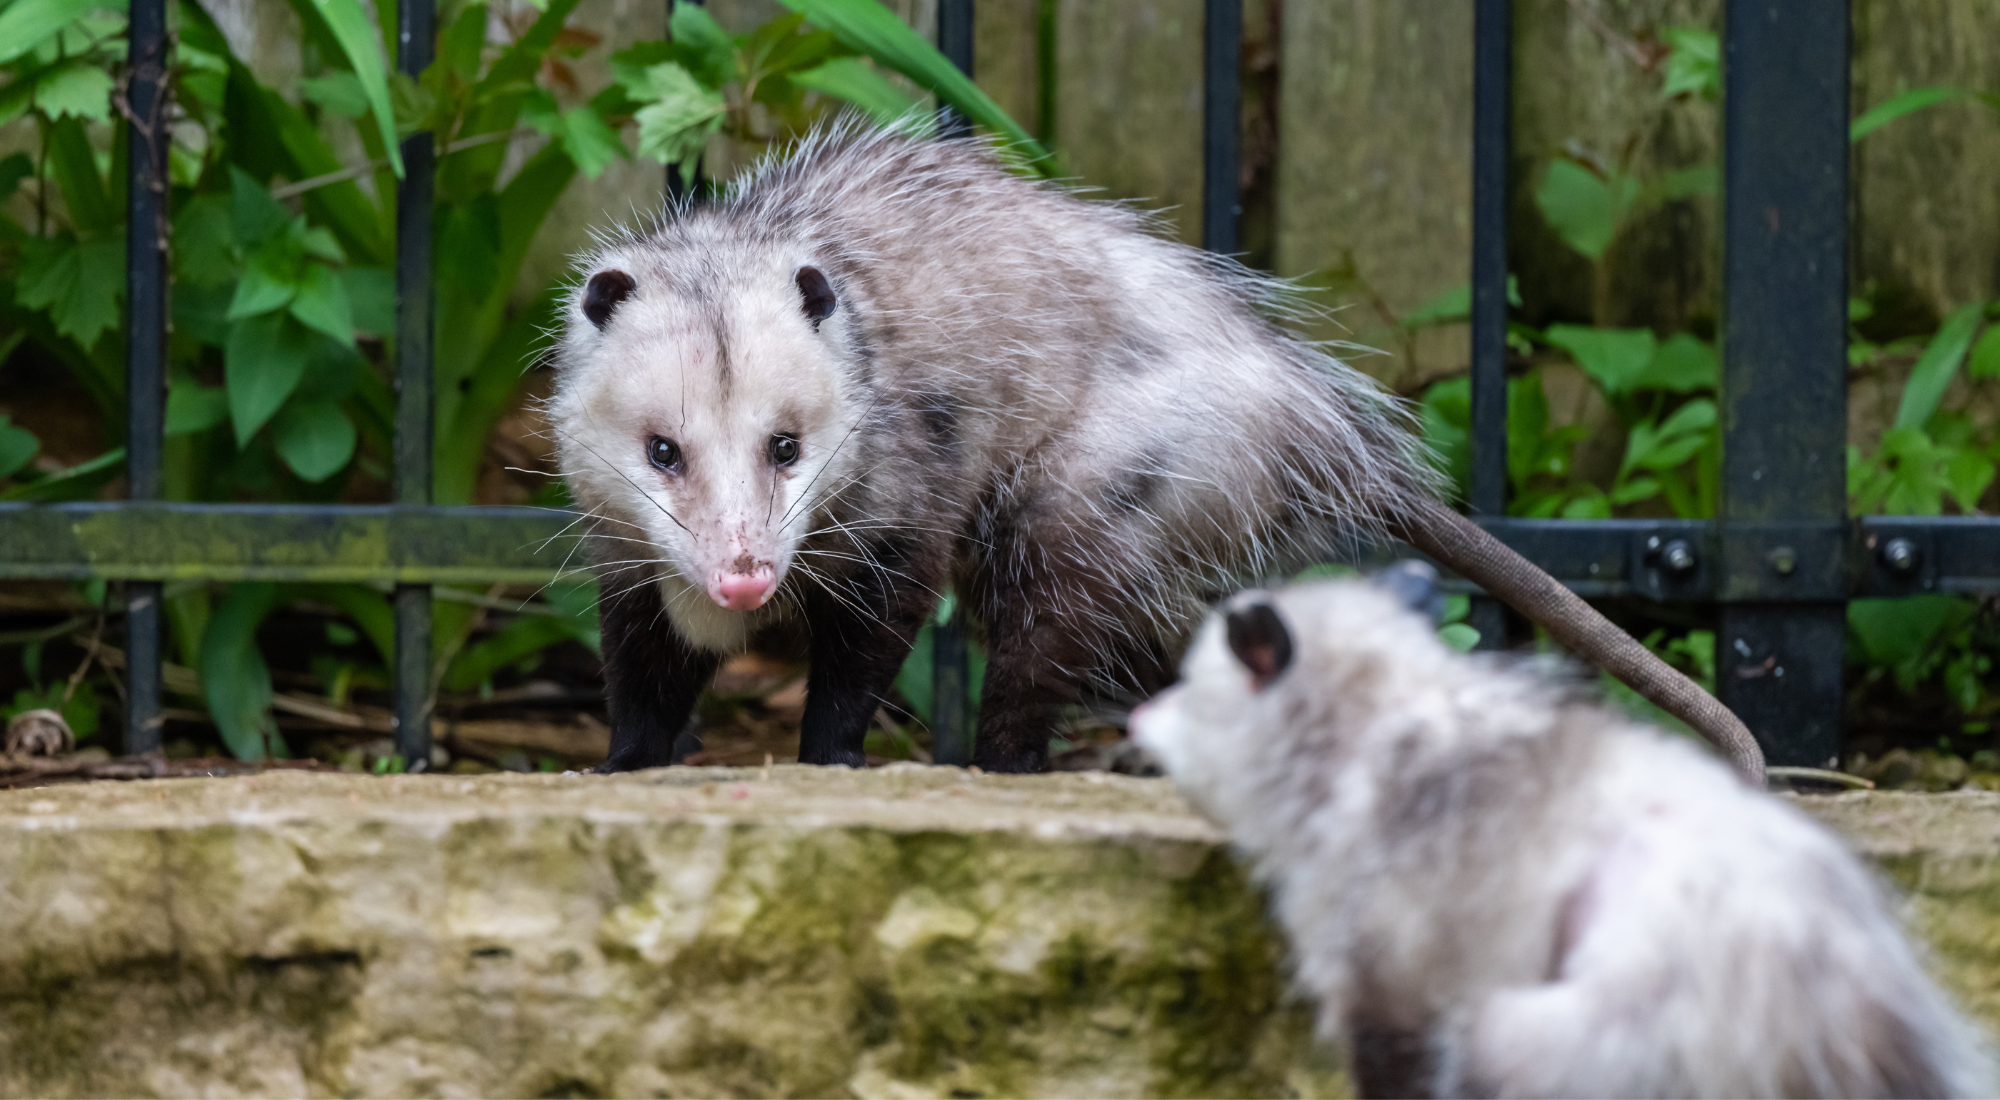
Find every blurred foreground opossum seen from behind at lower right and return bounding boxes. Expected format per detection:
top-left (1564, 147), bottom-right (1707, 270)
top-left (1132, 580), bottom-right (1994, 1096)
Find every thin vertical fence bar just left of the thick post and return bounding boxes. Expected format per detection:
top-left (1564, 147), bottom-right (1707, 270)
top-left (1472, 0), bottom-right (1514, 648)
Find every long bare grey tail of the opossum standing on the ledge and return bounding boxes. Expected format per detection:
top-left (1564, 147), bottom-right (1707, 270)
top-left (1396, 502), bottom-right (1764, 786)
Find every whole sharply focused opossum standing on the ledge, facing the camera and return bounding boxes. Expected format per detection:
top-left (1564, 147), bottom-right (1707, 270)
top-left (550, 128), bottom-right (1762, 776)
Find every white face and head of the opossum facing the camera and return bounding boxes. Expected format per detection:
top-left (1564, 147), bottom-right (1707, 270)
top-left (552, 246), bottom-right (868, 650)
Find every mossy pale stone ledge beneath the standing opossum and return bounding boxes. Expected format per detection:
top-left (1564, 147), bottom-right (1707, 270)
top-left (0, 780), bottom-right (2000, 1096)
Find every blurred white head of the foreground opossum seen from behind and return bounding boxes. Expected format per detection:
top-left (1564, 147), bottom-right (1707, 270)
top-left (1132, 574), bottom-right (1458, 822)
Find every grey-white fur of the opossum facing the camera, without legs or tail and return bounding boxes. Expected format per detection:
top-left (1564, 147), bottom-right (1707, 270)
top-left (550, 122), bottom-right (1434, 672)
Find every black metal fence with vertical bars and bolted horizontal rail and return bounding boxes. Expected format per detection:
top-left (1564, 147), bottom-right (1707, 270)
top-left (0, 0), bottom-right (2000, 770)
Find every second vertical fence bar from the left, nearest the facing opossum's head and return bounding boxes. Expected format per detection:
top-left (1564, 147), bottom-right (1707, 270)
top-left (396, 0), bottom-right (436, 772)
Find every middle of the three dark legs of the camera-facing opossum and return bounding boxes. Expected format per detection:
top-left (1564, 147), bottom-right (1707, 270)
top-left (798, 546), bottom-right (944, 768)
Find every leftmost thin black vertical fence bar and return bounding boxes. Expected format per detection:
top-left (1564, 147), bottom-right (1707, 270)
top-left (126, 0), bottom-right (170, 754)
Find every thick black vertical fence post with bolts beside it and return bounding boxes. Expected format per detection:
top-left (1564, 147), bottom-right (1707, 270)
top-left (1716, 0), bottom-right (1848, 766)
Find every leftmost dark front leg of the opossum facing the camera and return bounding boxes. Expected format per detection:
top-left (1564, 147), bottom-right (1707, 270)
top-left (596, 574), bottom-right (720, 772)
